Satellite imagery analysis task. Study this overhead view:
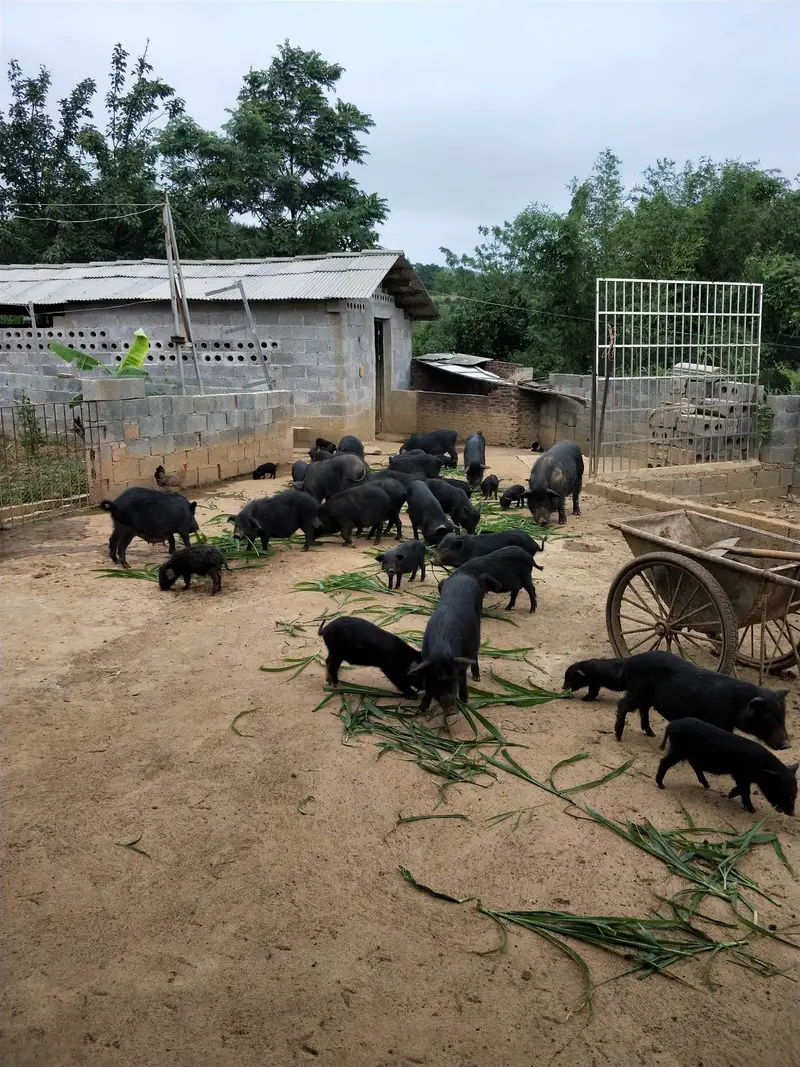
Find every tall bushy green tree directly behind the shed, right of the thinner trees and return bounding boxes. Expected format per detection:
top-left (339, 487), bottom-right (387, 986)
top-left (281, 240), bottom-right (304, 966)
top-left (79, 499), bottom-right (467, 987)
top-left (161, 41), bottom-right (387, 255)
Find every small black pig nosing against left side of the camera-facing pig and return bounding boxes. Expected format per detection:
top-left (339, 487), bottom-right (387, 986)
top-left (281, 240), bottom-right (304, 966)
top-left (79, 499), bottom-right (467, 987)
top-left (317, 616), bottom-right (422, 700)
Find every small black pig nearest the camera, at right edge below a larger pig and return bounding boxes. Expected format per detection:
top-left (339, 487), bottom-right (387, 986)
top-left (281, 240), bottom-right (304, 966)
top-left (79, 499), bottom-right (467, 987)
top-left (656, 718), bottom-right (800, 815)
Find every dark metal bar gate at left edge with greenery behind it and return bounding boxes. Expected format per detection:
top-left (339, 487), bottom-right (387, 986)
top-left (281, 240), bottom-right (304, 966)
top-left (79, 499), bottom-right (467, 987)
top-left (0, 394), bottom-right (100, 526)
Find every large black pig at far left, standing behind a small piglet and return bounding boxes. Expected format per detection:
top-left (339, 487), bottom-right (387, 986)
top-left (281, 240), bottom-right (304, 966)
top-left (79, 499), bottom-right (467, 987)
top-left (100, 487), bottom-right (198, 567)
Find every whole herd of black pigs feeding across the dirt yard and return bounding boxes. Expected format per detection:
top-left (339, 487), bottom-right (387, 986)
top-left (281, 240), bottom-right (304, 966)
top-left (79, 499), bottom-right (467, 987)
top-left (101, 430), bottom-right (798, 815)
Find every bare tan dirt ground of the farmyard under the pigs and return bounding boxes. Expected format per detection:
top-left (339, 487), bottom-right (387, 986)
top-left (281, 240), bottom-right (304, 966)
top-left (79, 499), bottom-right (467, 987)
top-left (0, 443), bottom-right (800, 1067)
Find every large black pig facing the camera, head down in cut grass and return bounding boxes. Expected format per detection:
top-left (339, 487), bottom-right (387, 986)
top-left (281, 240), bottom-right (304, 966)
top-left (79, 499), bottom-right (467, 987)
top-left (410, 574), bottom-right (498, 716)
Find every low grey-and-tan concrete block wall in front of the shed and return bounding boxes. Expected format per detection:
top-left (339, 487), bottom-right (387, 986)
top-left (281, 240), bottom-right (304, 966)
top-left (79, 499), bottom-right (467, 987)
top-left (83, 379), bottom-right (292, 504)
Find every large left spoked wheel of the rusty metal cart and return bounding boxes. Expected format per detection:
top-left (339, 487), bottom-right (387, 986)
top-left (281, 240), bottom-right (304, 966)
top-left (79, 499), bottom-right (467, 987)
top-left (606, 552), bottom-right (737, 674)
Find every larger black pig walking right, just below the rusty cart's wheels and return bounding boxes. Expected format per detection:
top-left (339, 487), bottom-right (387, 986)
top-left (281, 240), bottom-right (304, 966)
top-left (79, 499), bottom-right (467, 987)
top-left (614, 652), bottom-right (789, 748)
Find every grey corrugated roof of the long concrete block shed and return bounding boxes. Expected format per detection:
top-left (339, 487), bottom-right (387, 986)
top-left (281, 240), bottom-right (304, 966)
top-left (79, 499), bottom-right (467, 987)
top-left (0, 249), bottom-right (438, 319)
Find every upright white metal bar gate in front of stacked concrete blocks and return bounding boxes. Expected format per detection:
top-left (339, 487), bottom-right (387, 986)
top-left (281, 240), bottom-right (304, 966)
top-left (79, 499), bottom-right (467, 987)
top-left (591, 277), bottom-right (762, 471)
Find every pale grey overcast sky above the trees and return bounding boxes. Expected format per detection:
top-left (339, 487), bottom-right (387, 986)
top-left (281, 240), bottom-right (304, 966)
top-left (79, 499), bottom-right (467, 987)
top-left (0, 0), bottom-right (800, 261)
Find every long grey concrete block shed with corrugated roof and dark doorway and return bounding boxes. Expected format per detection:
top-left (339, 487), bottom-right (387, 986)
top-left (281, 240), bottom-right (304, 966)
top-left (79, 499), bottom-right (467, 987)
top-left (0, 250), bottom-right (437, 437)
